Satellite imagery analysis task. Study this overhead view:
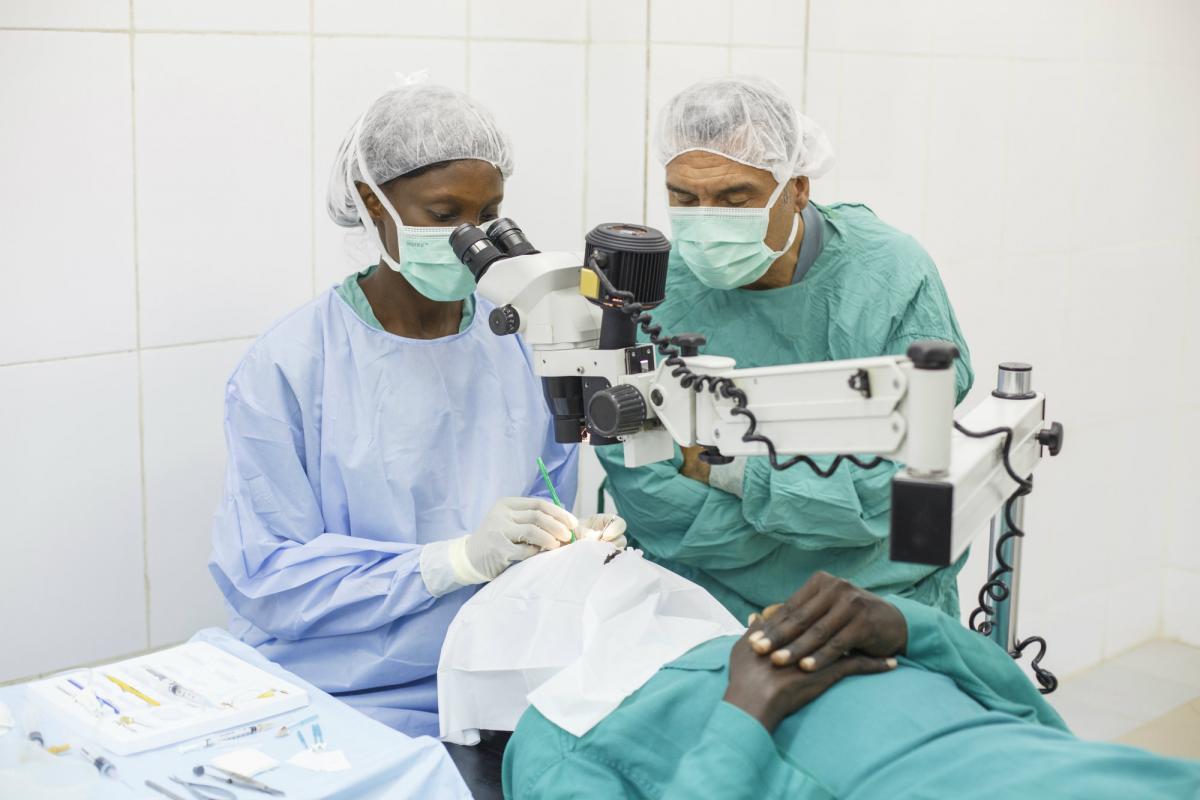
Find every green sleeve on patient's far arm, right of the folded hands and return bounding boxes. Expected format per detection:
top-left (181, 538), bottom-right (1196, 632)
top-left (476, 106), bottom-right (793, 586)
top-left (887, 595), bottom-right (1069, 730)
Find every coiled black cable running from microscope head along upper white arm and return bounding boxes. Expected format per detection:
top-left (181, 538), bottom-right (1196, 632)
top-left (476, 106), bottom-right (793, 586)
top-left (589, 259), bottom-right (884, 477)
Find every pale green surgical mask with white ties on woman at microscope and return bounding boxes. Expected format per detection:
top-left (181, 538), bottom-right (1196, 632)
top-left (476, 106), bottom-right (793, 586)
top-left (347, 115), bottom-right (475, 302)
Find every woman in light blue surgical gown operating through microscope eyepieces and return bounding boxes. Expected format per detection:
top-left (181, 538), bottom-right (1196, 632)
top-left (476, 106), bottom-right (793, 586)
top-left (209, 84), bottom-right (624, 735)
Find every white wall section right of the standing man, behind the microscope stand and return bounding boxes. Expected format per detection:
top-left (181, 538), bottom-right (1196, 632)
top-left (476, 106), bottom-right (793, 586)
top-left (806, 0), bottom-right (1200, 674)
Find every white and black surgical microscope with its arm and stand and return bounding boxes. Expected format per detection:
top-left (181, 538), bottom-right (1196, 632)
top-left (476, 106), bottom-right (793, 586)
top-left (450, 218), bottom-right (1063, 692)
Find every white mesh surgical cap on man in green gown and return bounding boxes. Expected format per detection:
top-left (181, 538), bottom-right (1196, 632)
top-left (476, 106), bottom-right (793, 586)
top-left (654, 76), bottom-right (834, 182)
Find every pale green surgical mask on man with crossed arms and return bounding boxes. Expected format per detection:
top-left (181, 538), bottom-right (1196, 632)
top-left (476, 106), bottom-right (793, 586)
top-left (667, 166), bottom-right (800, 289)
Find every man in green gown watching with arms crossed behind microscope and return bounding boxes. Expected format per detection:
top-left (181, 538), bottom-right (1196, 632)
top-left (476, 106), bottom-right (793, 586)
top-left (598, 77), bottom-right (973, 619)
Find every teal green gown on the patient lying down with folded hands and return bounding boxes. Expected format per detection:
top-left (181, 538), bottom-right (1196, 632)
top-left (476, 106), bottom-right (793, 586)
top-left (503, 597), bottom-right (1200, 800)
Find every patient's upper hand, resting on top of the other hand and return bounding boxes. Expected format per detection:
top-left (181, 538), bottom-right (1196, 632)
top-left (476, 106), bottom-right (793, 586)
top-left (749, 572), bottom-right (908, 672)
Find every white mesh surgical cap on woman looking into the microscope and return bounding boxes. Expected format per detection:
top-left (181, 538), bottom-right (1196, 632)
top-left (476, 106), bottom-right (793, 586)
top-left (326, 83), bottom-right (512, 228)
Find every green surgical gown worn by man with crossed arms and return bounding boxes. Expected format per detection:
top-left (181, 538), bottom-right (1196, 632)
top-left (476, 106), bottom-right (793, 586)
top-left (596, 203), bottom-right (973, 619)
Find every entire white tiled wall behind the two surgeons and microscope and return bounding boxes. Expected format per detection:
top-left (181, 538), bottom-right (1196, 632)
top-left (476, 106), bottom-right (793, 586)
top-left (0, 0), bottom-right (1200, 680)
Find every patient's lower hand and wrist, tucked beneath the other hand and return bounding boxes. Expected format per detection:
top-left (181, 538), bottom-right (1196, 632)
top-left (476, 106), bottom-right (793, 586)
top-left (724, 614), bottom-right (896, 733)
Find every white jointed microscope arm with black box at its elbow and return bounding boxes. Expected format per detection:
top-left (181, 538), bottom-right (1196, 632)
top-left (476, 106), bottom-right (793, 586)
top-left (601, 356), bottom-right (1049, 566)
